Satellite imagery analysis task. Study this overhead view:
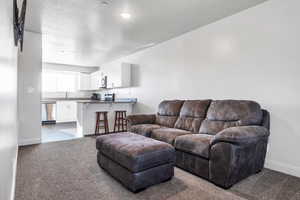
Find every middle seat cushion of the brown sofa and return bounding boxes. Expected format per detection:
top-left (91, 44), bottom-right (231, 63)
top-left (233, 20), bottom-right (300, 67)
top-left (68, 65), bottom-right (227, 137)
top-left (151, 128), bottom-right (192, 145)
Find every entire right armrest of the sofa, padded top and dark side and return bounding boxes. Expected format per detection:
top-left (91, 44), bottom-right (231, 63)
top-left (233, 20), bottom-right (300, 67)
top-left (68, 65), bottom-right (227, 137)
top-left (209, 126), bottom-right (270, 188)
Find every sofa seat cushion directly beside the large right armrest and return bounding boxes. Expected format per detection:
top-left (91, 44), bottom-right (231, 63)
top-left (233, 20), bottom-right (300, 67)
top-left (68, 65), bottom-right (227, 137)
top-left (174, 134), bottom-right (214, 159)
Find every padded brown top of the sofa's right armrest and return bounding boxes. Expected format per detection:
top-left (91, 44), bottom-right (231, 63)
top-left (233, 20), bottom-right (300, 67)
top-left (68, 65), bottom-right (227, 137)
top-left (211, 126), bottom-right (270, 146)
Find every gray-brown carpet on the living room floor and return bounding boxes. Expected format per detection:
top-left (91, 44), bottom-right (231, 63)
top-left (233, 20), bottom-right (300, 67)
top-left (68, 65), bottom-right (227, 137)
top-left (15, 138), bottom-right (300, 200)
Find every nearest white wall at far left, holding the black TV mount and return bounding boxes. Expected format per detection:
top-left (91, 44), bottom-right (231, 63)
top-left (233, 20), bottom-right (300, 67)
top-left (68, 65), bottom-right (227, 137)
top-left (0, 0), bottom-right (18, 200)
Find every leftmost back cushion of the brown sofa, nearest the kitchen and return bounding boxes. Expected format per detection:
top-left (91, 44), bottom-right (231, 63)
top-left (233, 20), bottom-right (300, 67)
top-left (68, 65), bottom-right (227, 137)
top-left (156, 100), bottom-right (183, 128)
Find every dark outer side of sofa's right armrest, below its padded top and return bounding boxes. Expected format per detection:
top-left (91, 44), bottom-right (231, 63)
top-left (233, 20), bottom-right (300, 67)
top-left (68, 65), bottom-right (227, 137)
top-left (209, 137), bottom-right (268, 189)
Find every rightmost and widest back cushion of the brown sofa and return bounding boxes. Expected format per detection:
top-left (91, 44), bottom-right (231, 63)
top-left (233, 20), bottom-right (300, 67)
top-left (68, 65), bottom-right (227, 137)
top-left (199, 100), bottom-right (263, 135)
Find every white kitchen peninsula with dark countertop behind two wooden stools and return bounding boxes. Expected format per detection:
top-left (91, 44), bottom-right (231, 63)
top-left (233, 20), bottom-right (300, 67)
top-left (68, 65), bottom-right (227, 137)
top-left (77, 99), bottom-right (137, 135)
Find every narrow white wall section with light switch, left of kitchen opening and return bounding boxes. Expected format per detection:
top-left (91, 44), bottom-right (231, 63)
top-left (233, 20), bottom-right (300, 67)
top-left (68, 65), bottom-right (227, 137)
top-left (18, 32), bottom-right (42, 145)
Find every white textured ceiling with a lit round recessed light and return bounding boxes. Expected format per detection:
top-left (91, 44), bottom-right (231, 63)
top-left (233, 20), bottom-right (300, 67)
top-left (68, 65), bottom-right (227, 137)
top-left (26, 0), bottom-right (266, 66)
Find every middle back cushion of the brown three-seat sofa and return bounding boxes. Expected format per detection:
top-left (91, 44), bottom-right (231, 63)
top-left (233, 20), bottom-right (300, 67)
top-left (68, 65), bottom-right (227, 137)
top-left (175, 100), bottom-right (211, 133)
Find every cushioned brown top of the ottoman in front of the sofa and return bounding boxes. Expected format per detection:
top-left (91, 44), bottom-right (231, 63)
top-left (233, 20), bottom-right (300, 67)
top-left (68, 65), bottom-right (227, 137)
top-left (96, 132), bottom-right (175, 173)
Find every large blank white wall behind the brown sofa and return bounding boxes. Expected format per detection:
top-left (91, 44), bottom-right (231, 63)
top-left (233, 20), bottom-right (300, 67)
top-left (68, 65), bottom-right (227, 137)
top-left (102, 0), bottom-right (300, 176)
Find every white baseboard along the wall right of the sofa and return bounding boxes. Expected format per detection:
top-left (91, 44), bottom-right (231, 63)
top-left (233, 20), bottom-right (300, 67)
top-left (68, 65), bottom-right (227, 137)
top-left (265, 160), bottom-right (300, 177)
